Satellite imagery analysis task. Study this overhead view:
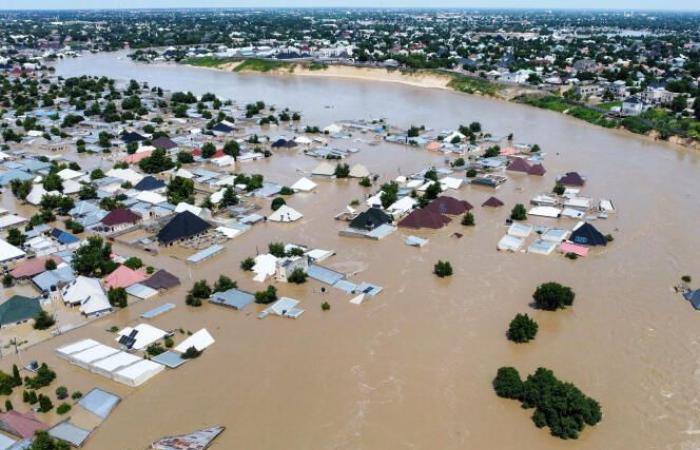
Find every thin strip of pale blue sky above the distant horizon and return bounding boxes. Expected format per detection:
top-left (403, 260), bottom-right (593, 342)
top-left (0, 0), bottom-right (700, 11)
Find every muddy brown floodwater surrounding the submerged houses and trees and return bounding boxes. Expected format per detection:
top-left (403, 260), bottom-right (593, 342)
top-left (1, 53), bottom-right (700, 450)
